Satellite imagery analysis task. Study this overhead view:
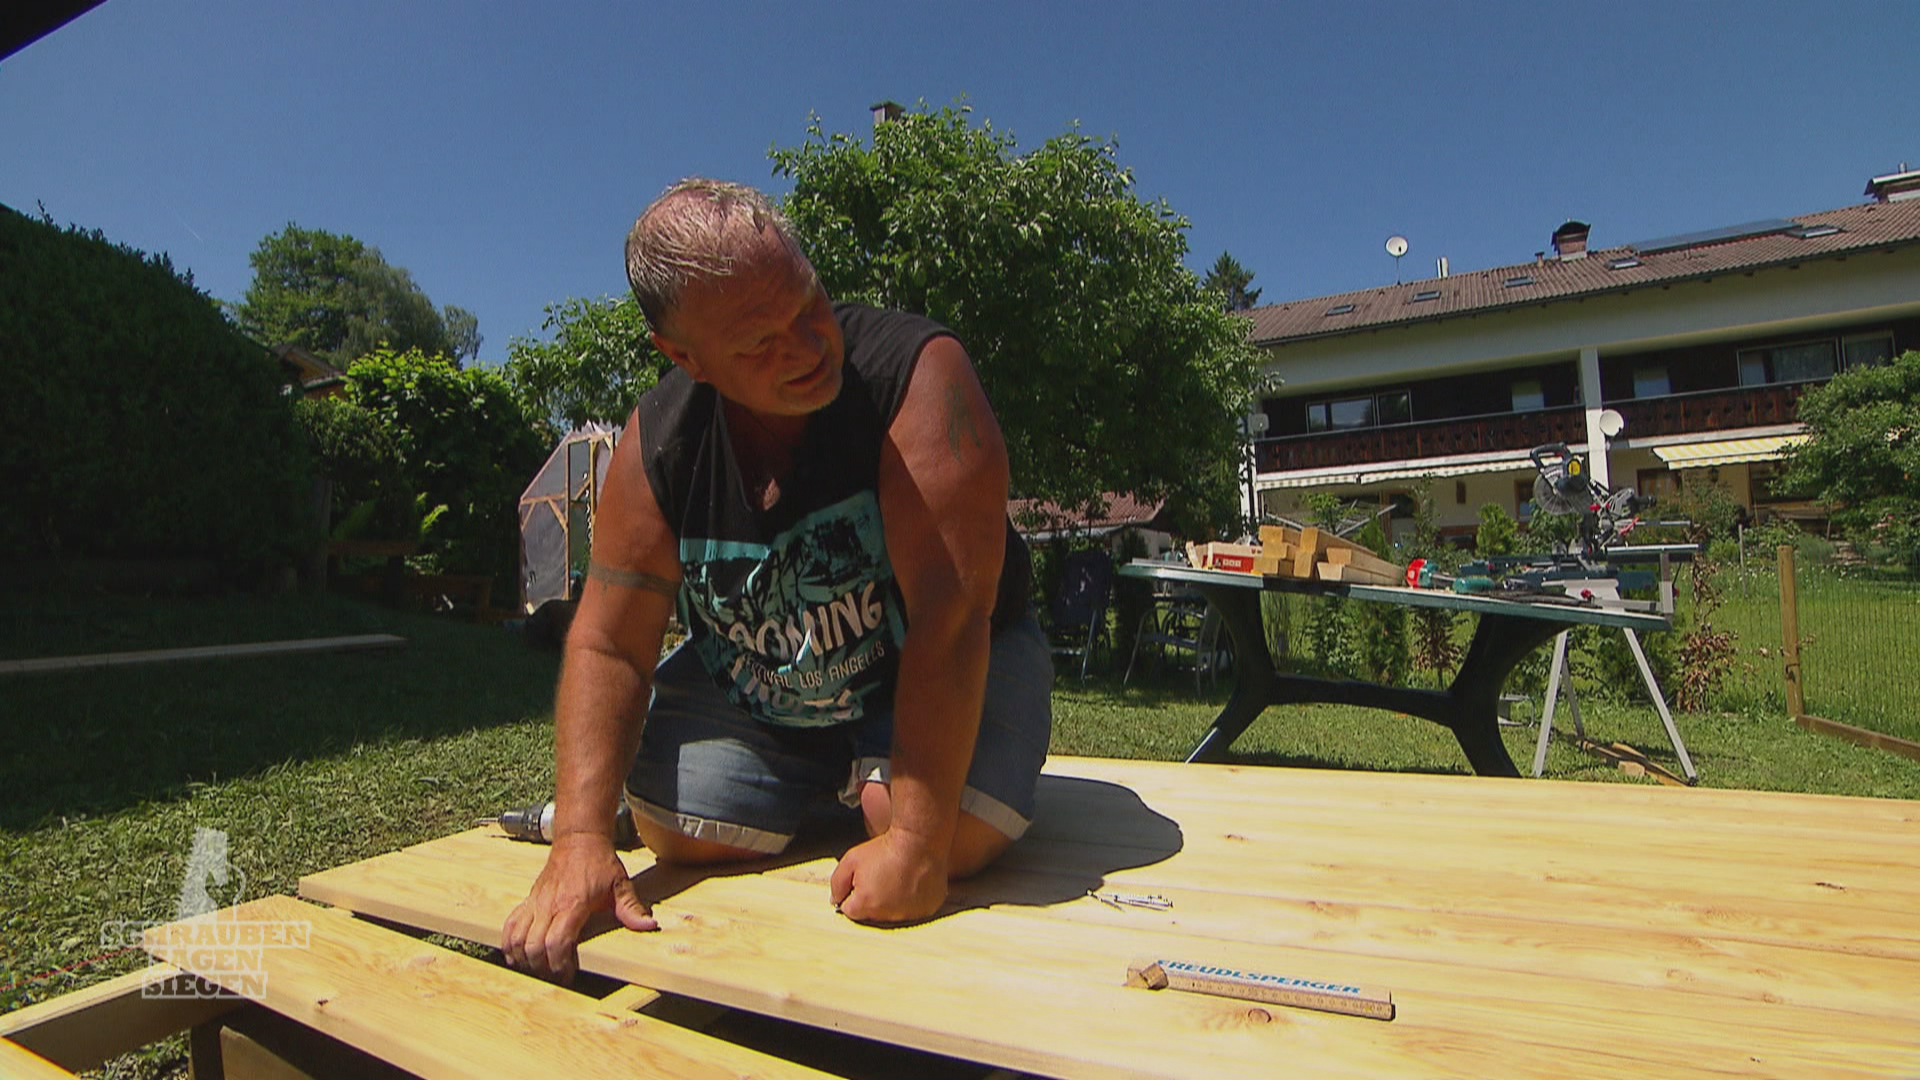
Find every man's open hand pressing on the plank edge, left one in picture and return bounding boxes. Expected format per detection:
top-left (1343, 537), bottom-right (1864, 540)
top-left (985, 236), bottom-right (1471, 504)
top-left (501, 834), bottom-right (660, 984)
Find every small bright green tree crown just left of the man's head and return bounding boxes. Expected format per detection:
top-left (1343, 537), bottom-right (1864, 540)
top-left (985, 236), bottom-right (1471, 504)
top-left (505, 296), bottom-right (672, 429)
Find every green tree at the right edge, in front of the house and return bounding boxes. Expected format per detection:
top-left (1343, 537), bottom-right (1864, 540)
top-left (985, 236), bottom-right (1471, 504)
top-left (1782, 352), bottom-right (1920, 571)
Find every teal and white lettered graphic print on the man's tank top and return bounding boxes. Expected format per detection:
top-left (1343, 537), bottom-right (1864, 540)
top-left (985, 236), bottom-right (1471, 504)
top-left (680, 492), bottom-right (906, 726)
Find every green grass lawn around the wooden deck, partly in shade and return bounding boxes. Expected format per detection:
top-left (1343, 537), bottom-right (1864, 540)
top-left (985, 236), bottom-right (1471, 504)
top-left (0, 596), bottom-right (1920, 1076)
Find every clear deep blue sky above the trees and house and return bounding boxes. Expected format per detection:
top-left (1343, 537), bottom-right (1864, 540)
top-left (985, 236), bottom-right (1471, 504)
top-left (0, 0), bottom-right (1920, 361)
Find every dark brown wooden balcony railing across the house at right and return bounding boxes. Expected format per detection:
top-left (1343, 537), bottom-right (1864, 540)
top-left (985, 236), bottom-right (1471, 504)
top-left (1256, 382), bottom-right (1812, 473)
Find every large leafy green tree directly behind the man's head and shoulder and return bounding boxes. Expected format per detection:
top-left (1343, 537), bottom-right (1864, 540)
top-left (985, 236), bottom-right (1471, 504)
top-left (772, 106), bottom-right (1260, 530)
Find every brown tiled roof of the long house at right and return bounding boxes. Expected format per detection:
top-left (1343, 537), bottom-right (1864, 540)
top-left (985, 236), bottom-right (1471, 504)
top-left (1248, 200), bottom-right (1920, 346)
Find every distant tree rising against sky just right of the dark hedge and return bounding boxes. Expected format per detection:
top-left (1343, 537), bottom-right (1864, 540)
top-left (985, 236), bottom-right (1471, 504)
top-left (232, 223), bottom-right (480, 369)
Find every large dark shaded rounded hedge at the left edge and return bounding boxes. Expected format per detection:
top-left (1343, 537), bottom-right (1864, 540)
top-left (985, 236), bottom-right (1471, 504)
top-left (0, 206), bottom-right (315, 571)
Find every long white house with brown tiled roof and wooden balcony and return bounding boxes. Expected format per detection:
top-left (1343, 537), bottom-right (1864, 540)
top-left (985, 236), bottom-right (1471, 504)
top-left (1250, 174), bottom-right (1920, 532)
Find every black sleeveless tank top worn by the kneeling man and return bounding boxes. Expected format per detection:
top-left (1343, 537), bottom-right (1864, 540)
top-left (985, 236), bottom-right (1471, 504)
top-left (639, 304), bottom-right (1033, 726)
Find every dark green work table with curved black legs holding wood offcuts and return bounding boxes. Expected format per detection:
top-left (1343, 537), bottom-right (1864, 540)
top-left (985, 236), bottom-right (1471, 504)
top-left (1119, 559), bottom-right (1672, 776)
